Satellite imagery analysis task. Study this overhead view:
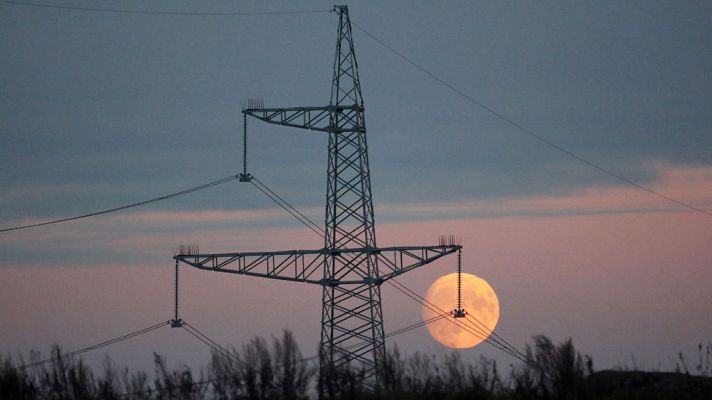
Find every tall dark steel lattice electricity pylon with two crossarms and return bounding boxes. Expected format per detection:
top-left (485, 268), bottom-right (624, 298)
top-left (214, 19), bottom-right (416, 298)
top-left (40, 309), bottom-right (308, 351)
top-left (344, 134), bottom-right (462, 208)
top-left (174, 6), bottom-right (461, 385)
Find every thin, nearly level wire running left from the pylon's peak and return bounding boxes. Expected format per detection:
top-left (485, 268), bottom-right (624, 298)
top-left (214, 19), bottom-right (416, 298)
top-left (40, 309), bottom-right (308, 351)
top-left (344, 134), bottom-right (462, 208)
top-left (1, 0), bottom-right (330, 17)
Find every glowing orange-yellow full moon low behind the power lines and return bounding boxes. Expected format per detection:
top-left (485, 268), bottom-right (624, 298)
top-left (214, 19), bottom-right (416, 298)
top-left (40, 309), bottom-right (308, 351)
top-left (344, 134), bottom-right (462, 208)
top-left (423, 273), bottom-right (499, 349)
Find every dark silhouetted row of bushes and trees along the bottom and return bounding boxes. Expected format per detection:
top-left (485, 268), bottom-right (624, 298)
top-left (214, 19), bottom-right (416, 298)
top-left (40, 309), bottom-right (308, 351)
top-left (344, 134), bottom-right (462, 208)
top-left (0, 331), bottom-right (712, 400)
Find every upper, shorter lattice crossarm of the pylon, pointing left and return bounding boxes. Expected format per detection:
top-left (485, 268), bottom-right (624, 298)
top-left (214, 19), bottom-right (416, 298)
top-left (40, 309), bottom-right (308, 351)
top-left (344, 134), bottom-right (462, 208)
top-left (242, 105), bottom-right (363, 132)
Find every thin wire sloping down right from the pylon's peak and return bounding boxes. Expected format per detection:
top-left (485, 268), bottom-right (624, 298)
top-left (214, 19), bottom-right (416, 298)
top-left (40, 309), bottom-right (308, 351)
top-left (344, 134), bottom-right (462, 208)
top-left (351, 22), bottom-right (712, 217)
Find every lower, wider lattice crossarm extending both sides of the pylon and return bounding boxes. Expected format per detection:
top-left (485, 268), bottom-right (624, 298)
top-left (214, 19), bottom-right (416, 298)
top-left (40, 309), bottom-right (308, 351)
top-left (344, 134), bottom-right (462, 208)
top-left (174, 246), bottom-right (460, 286)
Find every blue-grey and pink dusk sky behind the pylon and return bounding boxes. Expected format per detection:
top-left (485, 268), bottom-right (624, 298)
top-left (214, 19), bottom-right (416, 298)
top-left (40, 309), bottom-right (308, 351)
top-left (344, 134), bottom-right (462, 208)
top-left (0, 0), bottom-right (712, 369)
